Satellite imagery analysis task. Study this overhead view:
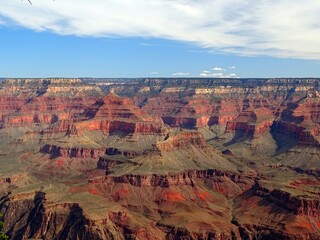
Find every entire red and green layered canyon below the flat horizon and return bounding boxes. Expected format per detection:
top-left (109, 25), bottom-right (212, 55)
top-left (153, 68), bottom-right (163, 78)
top-left (0, 78), bottom-right (320, 240)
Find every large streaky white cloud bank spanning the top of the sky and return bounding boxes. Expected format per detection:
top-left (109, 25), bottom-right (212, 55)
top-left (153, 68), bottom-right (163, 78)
top-left (0, 0), bottom-right (320, 59)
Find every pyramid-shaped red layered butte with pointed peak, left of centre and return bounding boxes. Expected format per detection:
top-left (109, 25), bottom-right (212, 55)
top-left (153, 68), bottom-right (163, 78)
top-left (60, 93), bottom-right (163, 134)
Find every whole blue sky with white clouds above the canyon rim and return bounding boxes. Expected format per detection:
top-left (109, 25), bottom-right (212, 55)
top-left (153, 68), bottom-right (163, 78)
top-left (0, 0), bottom-right (320, 78)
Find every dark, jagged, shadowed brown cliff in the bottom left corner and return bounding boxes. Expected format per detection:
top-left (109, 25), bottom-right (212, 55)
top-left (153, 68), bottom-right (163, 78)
top-left (1, 192), bottom-right (123, 239)
